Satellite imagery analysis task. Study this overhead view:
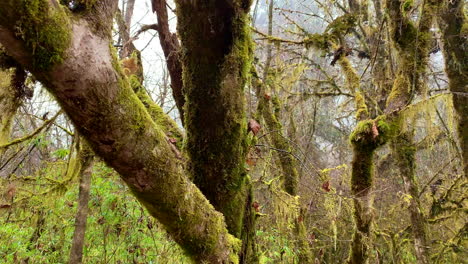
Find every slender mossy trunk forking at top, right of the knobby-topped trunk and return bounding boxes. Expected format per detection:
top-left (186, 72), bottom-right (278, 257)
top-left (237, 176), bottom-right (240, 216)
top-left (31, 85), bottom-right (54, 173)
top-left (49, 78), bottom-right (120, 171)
top-left (386, 0), bottom-right (440, 264)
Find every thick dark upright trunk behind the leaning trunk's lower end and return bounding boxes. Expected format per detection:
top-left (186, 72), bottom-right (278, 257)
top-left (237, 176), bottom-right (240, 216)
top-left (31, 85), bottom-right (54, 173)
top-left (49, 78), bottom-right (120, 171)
top-left (176, 0), bottom-right (254, 263)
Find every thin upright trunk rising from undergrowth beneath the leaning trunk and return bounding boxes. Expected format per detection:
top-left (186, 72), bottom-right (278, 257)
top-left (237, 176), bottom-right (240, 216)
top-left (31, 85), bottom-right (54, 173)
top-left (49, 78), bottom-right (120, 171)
top-left (68, 138), bottom-right (94, 264)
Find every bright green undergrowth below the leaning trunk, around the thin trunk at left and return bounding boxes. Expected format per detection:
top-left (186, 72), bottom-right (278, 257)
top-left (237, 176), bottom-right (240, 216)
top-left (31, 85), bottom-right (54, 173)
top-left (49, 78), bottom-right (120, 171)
top-left (0, 161), bottom-right (189, 263)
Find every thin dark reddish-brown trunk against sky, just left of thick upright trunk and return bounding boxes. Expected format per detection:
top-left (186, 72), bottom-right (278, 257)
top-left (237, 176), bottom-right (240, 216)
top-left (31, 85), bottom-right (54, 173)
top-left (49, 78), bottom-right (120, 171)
top-left (151, 0), bottom-right (185, 124)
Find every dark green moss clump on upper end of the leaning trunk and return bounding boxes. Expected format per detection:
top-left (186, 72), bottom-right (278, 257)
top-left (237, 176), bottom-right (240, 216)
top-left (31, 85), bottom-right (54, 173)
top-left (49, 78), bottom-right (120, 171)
top-left (15, 0), bottom-right (71, 71)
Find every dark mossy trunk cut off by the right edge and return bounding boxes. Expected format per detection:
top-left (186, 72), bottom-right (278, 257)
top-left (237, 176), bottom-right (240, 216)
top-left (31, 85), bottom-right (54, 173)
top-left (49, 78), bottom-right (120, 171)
top-left (438, 0), bottom-right (468, 177)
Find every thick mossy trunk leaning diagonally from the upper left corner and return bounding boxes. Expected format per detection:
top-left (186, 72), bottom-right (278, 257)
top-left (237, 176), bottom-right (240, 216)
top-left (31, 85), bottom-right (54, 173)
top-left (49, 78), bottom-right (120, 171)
top-left (0, 0), bottom-right (241, 263)
